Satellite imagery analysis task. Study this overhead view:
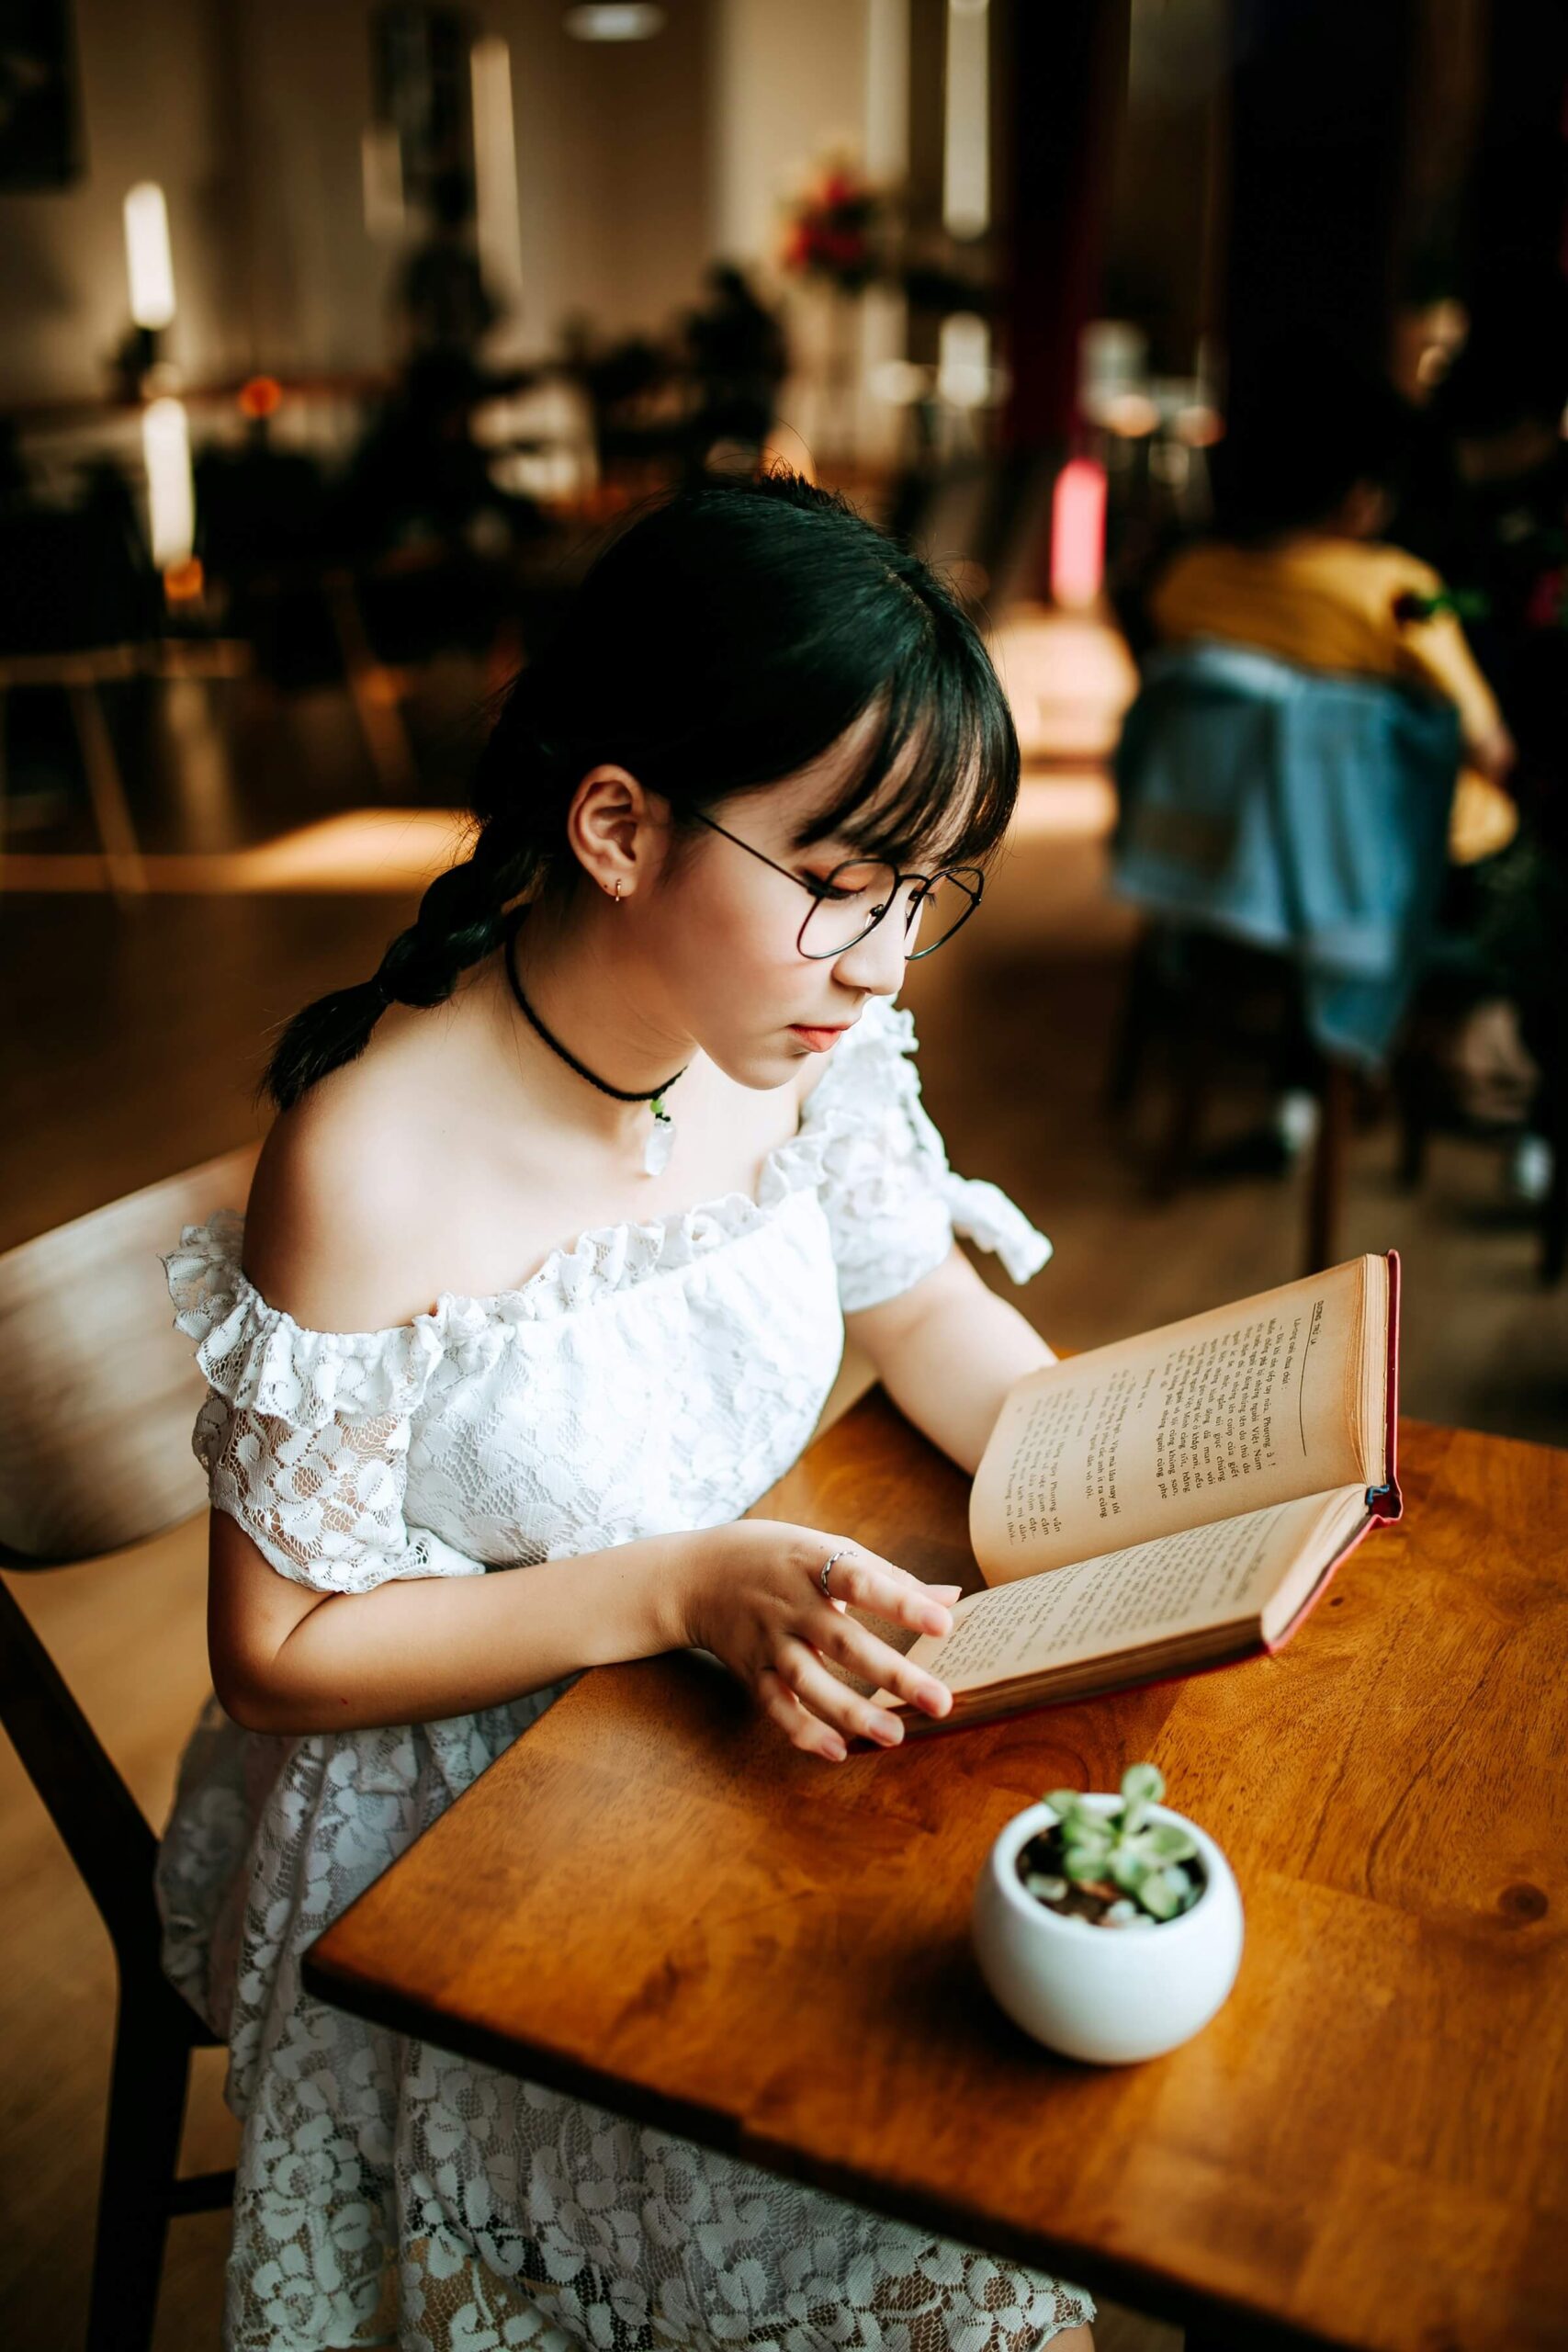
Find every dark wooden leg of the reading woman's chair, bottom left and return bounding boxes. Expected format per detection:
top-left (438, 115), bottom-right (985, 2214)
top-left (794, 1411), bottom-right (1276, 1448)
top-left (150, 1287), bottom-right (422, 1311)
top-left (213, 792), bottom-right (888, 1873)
top-left (87, 1978), bottom-right (190, 2352)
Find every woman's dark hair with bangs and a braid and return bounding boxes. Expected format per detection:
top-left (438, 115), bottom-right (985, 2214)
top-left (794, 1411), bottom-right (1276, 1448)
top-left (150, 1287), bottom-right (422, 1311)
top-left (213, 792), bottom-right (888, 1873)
top-left (265, 473), bottom-right (1018, 1110)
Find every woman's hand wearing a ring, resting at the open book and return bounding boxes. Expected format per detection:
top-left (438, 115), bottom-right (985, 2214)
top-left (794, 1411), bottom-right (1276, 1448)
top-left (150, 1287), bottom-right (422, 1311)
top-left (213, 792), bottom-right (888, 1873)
top-left (682, 1520), bottom-right (964, 1764)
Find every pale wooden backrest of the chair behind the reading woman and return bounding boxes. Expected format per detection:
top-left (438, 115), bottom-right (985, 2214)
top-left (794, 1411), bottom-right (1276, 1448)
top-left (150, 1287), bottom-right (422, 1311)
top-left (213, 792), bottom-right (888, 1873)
top-left (0, 1148), bottom-right (256, 1566)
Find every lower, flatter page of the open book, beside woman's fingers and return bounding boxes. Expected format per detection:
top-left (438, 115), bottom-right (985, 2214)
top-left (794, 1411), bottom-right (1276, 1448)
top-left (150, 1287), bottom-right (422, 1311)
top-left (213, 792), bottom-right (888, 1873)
top-left (879, 1487), bottom-right (1366, 1705)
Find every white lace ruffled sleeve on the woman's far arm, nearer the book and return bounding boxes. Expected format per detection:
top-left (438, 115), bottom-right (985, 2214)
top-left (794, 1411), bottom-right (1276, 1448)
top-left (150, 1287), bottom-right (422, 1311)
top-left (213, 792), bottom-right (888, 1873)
top-left (802, 1000), bottom-right (1051, 1315)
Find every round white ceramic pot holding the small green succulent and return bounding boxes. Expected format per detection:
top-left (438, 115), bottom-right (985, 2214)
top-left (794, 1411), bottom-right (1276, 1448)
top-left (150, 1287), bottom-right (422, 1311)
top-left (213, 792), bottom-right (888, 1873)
top-left (974, 1794), bottom-right (1241, 2065)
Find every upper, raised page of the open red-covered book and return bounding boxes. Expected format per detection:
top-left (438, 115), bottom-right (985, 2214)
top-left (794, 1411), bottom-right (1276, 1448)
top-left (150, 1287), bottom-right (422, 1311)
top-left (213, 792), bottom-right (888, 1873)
top-left (968, 1259), bottom-right (1387, 1585)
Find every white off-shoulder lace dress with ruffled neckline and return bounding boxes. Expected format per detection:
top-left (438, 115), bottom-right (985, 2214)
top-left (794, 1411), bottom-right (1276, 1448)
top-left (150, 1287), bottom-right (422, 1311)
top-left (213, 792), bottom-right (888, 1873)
top-left (160, 1004), bottom-right (1093, 2352)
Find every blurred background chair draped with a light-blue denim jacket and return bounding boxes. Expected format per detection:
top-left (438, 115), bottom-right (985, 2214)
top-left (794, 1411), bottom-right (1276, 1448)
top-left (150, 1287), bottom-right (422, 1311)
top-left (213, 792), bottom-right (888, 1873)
top-left (1112, 642), bottom-right (1460, 1268)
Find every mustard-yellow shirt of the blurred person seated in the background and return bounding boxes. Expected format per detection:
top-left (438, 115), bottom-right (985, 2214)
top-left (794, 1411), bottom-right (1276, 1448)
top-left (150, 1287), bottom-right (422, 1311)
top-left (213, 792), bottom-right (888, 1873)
top-left (1149, 534), bottom-right (1518, 865)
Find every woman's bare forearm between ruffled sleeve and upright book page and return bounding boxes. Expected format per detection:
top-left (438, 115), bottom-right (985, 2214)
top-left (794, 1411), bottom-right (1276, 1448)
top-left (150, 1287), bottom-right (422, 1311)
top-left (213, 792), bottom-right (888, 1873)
top-left (844, 1242), bottom-right (1055, 1477)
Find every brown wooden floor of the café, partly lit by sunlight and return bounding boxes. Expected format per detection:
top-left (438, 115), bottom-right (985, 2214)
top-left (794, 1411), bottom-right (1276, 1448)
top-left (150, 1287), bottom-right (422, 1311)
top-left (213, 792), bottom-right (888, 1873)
top-left (0, 611), bottom-right (1568, 2352)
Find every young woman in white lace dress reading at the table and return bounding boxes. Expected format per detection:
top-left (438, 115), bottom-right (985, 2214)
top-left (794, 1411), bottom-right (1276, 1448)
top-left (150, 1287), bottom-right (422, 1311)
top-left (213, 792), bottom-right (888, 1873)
top-left (163, 478), bottom-right (1090, 2352)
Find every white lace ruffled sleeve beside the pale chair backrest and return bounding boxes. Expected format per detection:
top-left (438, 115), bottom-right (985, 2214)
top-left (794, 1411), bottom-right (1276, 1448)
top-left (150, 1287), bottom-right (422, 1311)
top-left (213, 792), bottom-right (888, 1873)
top-left (164, 1211), bottom-right (484, 1592)
